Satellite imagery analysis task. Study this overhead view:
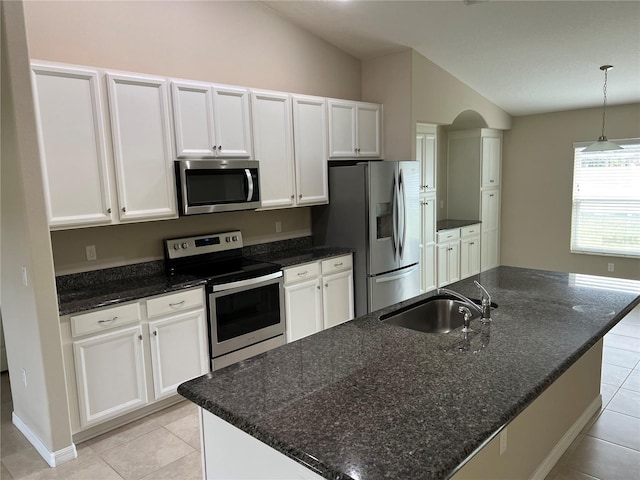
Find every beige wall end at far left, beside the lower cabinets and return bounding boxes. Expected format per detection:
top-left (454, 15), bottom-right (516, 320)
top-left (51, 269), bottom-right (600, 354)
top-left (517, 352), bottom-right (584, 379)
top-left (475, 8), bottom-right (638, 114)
top-left (0, 2), bottom-right (71, 452)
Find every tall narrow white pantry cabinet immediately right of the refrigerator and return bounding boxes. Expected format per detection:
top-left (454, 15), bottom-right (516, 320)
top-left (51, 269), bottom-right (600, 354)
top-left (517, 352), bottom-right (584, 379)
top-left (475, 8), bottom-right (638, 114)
top-left (416, 123), bottom-right (438, 293)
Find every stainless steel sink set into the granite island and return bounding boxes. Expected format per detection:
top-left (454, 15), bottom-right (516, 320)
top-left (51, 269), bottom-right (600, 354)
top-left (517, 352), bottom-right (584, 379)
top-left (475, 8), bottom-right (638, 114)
top-left (380, 297), bottom-right (482, 333)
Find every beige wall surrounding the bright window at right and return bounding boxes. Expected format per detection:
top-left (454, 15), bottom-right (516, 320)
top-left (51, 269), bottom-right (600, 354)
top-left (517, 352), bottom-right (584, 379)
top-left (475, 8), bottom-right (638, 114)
top-left (500, 104), bottom-right (640, 280)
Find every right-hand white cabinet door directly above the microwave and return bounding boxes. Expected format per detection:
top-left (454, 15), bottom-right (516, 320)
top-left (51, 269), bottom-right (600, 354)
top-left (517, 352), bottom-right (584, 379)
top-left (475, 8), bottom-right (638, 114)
top-left (213, 85), bottom-right (250, 160)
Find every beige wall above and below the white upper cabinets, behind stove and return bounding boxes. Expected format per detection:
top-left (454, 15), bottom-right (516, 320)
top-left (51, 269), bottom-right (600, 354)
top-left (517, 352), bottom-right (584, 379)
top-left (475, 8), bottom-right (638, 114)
top-left (25, 1), bottom-right (361, 274)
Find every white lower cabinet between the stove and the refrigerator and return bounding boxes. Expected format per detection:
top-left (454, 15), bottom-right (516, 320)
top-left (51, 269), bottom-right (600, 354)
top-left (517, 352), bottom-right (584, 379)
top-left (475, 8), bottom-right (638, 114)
top-left (284, 255), bottom-right (354, 342)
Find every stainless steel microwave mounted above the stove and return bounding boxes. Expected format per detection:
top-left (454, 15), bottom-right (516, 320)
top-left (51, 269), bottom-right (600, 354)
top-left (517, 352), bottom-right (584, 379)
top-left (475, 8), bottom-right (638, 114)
top-left (175, 160), bottom-right (260, 215)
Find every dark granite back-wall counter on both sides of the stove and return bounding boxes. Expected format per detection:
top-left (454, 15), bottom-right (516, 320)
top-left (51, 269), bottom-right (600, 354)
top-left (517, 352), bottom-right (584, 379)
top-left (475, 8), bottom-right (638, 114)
top-left (56, 244), bottom-right (353, 315)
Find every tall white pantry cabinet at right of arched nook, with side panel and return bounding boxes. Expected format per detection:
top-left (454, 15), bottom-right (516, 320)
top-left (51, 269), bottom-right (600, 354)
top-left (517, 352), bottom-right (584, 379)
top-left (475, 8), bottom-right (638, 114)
top-left (447, 128), bottom-right (502, 271)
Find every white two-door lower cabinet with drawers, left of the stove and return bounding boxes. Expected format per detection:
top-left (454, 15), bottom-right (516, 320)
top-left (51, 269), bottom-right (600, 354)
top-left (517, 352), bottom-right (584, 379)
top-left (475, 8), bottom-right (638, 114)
top-left (61, 287), bottom-right (209, 433)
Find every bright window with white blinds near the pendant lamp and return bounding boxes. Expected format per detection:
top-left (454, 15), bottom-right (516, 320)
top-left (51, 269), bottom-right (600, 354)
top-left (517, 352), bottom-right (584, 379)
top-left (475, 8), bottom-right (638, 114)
top-left (571, 139), bottom-right (640, 258)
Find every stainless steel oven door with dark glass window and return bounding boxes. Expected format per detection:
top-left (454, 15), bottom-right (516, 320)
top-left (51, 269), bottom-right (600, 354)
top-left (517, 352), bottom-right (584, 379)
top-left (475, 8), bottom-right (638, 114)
top-left (209, 271), bottom-right (285, 358)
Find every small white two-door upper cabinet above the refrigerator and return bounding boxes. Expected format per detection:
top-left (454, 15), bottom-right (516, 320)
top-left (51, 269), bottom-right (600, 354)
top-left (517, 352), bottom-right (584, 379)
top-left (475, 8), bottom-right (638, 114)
top-left (328, 99), bottom-right (382, 159)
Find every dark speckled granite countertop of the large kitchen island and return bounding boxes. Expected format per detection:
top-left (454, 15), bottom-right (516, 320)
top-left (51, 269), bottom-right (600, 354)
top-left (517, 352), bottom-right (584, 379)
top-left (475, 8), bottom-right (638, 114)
top-left (178, 267), bottom-right (640, 480)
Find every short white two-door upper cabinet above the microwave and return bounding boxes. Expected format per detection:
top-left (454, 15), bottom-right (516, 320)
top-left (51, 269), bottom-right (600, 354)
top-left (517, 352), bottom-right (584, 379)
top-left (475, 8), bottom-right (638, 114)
top-left (171, 80), bottom-right (252, 158)
